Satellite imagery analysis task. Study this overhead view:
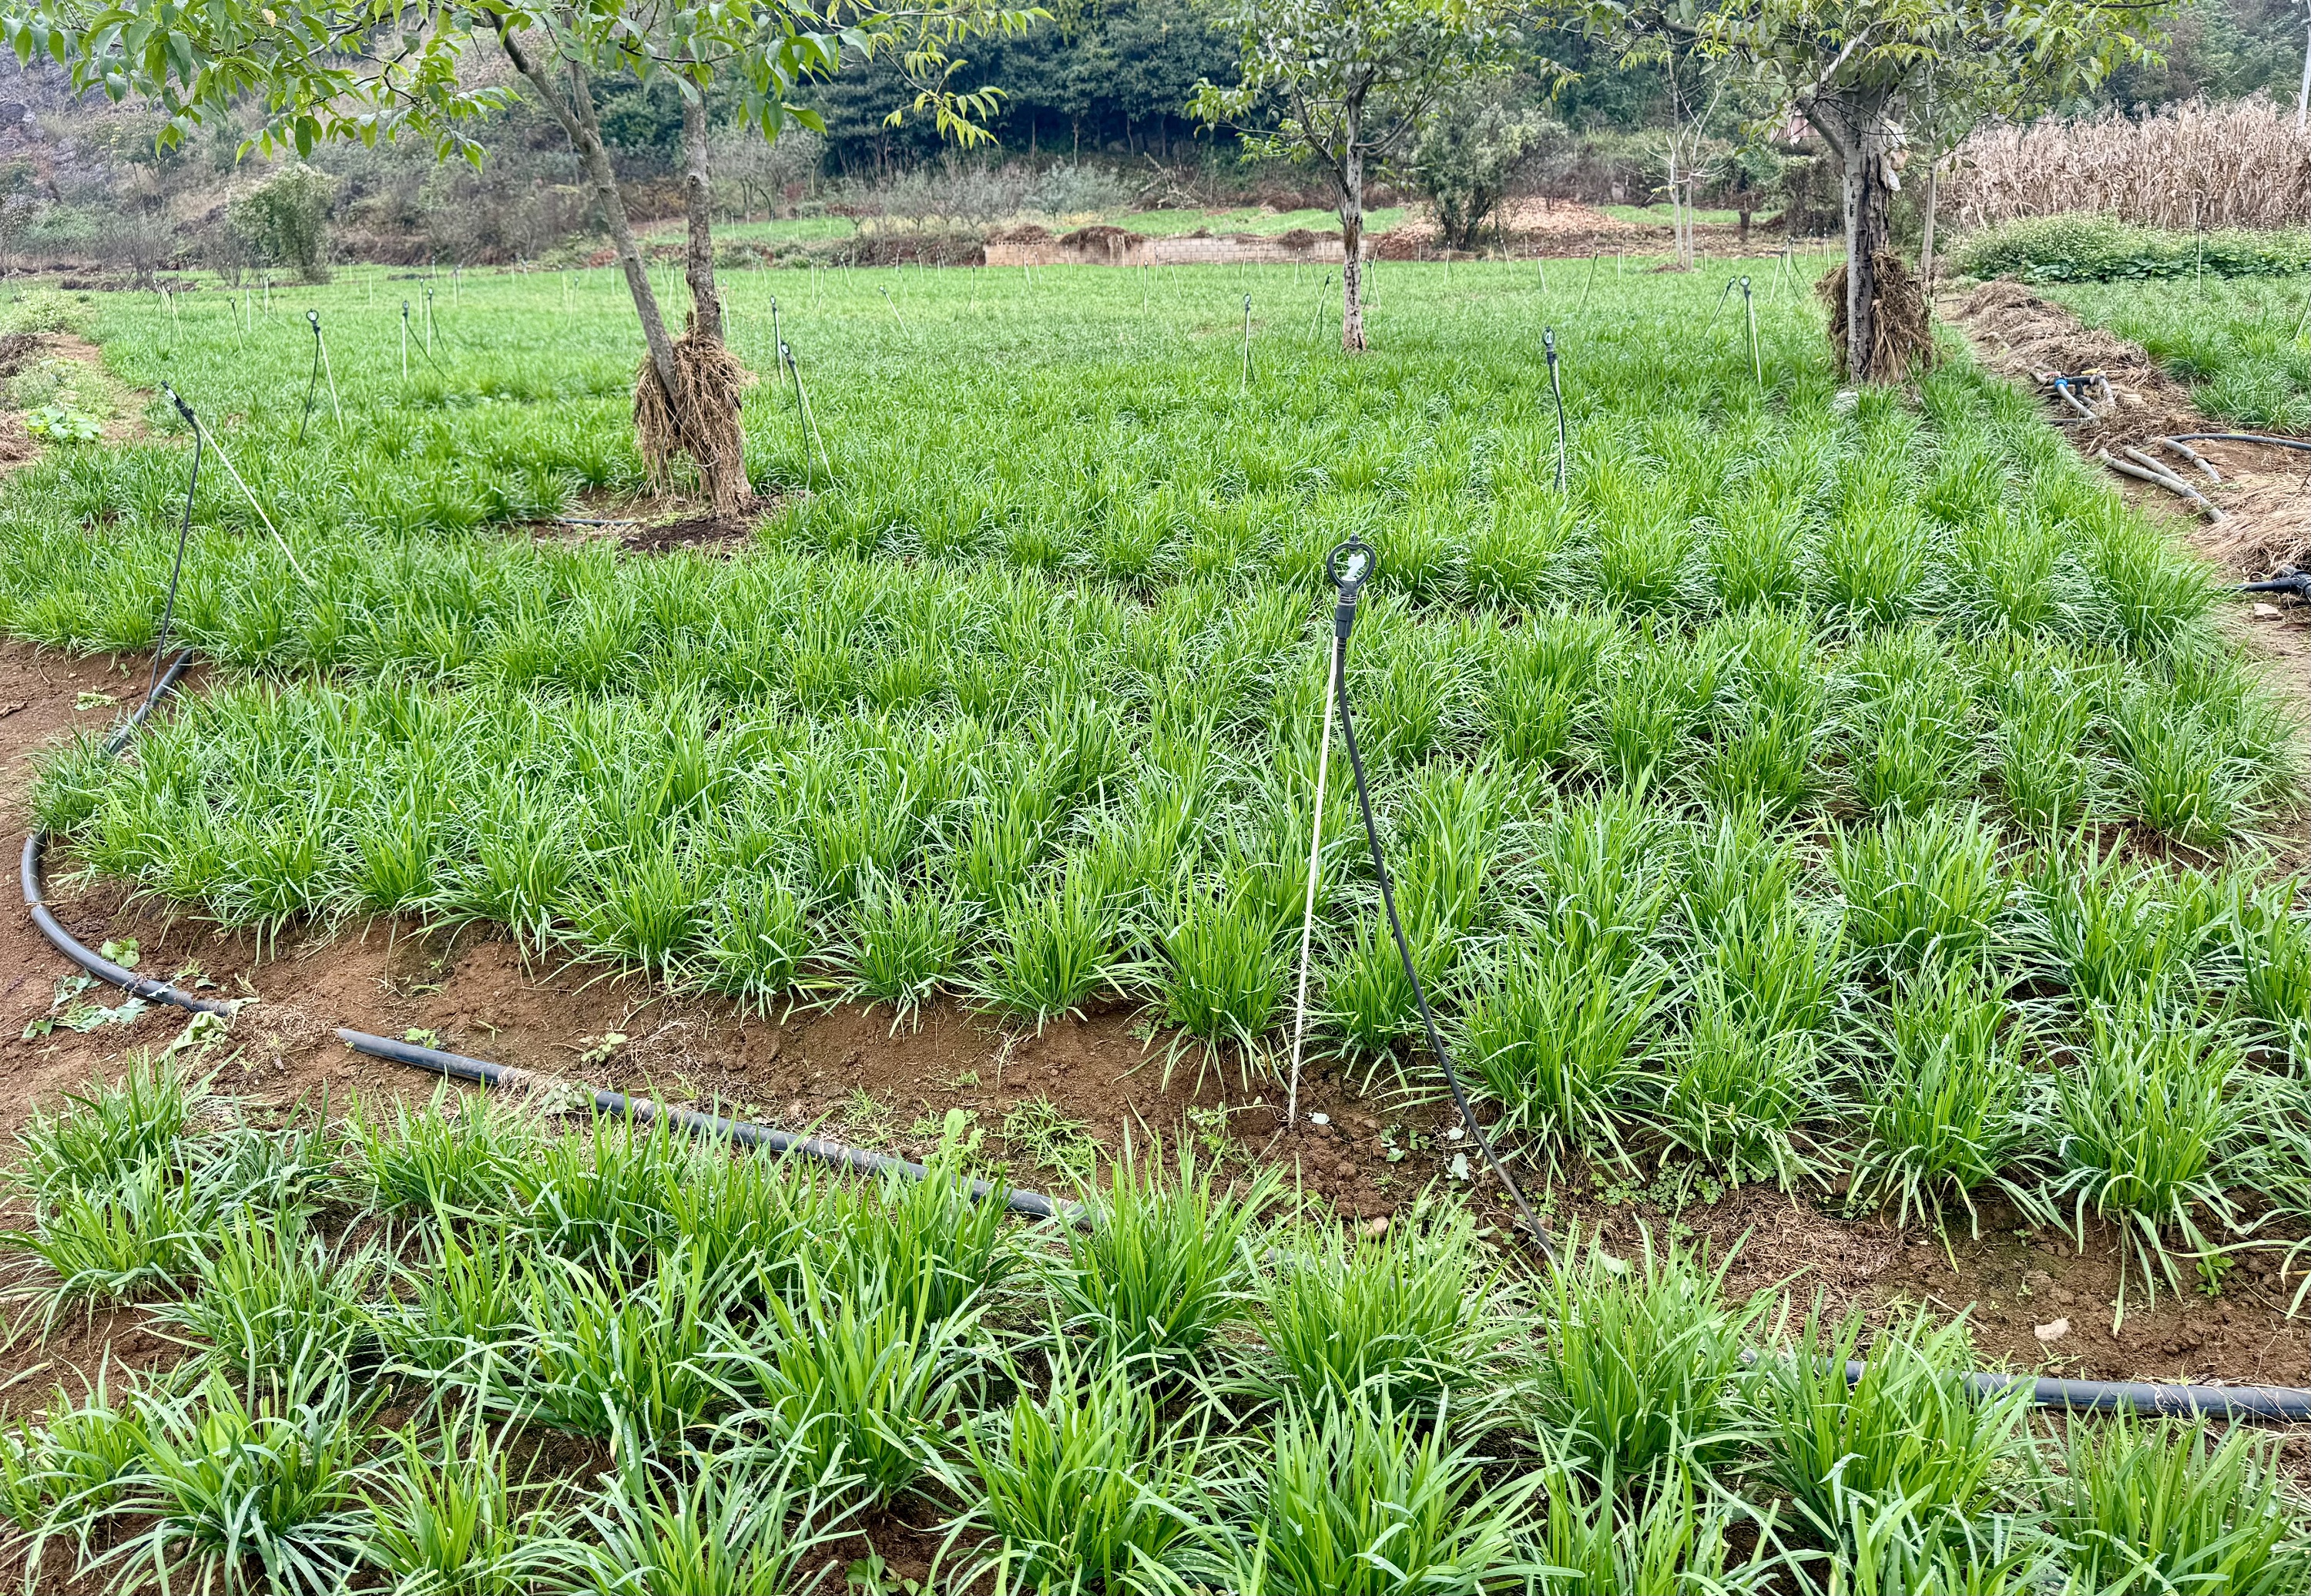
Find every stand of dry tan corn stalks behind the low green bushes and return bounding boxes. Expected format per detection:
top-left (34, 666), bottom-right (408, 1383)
top-left (1944, 99), bottom-right (2311, 226)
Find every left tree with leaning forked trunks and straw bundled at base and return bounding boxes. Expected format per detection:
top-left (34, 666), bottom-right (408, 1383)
top-left (12, 0), bottom-right (1033, 515)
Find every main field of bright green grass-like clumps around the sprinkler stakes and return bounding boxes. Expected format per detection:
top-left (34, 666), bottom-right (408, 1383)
top-left (0, 263), bottom-right (2311, 1591)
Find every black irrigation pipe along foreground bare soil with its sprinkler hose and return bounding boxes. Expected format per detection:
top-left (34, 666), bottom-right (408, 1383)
top-left (21, 424), bottom-right (2311, 1423)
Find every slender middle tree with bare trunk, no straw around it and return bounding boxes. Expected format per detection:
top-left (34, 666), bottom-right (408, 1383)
top-left (1188, 0), bottom-right (1525, 351)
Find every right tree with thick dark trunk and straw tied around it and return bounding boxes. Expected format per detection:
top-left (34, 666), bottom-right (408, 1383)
top-left (1590, 0), bottom-right (2170, 381)
